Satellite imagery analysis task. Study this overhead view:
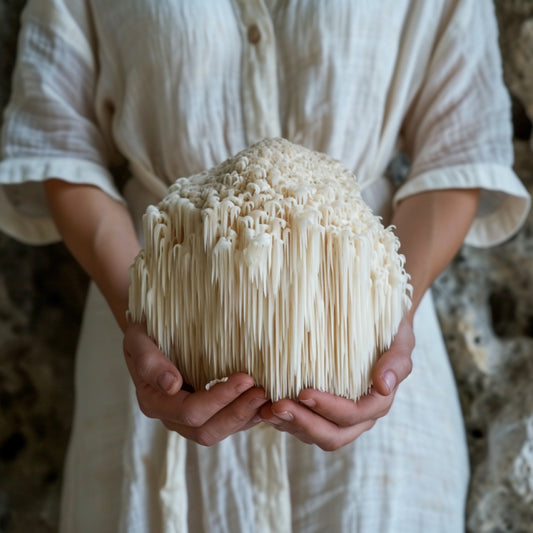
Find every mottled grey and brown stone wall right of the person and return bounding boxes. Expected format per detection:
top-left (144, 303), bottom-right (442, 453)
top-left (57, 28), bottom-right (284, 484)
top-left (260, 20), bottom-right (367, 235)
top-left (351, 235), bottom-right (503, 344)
top-left (435, 0), bottom-right (533, 533)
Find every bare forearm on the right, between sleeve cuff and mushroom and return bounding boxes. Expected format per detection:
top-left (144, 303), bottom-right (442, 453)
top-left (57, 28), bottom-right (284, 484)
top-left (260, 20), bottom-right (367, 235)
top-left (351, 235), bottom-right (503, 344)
top-left (392, 189), bottom-right (479, 321)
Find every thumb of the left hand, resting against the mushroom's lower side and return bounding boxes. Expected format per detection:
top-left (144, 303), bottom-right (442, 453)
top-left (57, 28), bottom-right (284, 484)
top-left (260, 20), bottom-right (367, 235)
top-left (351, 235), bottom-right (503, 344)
top-left (123, 324), bottom-right (183, 395)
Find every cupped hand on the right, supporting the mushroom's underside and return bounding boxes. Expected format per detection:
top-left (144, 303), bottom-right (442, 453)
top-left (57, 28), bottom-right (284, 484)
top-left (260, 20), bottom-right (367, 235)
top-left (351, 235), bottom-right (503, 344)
top-left (260, 319), bottom-right (415, 451)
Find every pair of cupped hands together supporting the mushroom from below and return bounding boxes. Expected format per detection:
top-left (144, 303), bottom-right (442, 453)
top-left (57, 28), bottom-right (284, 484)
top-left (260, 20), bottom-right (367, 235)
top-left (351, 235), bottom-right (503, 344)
top-left (124, 321), bottom-right (414, 451)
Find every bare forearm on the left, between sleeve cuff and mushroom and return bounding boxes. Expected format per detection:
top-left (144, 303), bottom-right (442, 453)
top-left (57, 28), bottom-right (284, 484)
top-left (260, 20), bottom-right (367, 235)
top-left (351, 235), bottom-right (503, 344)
top-left (45, 180), bottom-right (140, 329)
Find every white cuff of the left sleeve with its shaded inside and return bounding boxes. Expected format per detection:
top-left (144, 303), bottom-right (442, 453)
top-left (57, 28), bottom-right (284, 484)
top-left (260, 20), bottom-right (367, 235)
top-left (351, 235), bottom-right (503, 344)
top-left (0, 158), bottom-right (124, 244)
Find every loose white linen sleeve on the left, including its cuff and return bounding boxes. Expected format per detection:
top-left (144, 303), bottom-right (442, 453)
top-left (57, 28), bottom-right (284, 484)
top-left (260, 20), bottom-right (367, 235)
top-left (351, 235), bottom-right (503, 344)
top-left (0, 0), bottom-right (123, 244)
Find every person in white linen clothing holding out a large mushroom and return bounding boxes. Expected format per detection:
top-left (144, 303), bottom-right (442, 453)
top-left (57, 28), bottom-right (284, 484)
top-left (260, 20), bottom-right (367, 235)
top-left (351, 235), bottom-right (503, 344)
top-left (0, 0), bottom-right (530, 532)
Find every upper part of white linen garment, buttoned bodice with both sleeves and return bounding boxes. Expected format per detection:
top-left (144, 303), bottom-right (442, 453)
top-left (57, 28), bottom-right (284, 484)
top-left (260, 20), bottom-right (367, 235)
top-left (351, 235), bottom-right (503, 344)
top-left (0, 0), bottom-right (530, 246)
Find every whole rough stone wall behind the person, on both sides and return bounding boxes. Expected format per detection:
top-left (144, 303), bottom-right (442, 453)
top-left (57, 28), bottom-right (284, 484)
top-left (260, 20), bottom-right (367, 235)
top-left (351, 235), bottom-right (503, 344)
top-left (0, 0), bottom-right (533, 533)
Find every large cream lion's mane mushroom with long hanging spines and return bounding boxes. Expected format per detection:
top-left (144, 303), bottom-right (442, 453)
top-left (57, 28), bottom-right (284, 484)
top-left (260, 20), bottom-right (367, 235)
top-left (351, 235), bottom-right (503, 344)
top-left (129, 139), bottom-right (410, 400)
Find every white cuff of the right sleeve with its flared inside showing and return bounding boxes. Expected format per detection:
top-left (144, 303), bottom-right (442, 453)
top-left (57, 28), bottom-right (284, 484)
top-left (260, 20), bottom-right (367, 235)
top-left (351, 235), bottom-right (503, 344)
top-left (393, 164), bottom-right (531, 247)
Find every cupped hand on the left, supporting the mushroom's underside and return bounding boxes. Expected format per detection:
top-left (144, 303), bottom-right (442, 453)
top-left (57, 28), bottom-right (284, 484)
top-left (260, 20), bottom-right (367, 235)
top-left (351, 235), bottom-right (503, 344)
top-left (124, 323), bottom-right (267, 446)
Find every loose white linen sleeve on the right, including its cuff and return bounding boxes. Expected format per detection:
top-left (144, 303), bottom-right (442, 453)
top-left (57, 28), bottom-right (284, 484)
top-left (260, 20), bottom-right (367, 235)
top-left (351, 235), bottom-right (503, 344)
top-left (394, 0), bottom-right (531, 247)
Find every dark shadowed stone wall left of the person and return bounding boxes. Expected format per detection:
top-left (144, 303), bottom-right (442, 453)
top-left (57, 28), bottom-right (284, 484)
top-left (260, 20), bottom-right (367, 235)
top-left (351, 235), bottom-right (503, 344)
top-left (0, 0), bottom-right (87, 533)
